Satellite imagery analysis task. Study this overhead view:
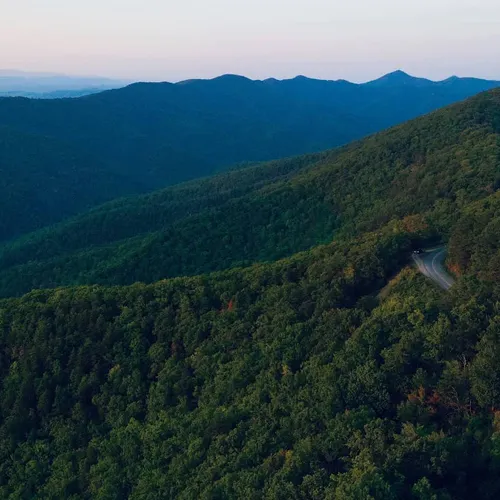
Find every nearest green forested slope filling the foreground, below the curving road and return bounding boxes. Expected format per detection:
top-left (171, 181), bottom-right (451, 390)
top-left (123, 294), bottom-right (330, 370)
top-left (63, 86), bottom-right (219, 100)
top-left (0, 217), bottom-right (500, 500)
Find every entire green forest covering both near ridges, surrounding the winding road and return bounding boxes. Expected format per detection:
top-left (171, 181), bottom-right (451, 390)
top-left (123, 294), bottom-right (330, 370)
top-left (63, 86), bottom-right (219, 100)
top-left (0, 91), bottom-right (500, 500)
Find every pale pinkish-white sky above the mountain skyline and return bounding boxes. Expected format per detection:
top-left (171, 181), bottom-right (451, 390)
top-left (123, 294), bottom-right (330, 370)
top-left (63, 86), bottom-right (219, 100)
top-left (0, 0), bottom-right (500, 82)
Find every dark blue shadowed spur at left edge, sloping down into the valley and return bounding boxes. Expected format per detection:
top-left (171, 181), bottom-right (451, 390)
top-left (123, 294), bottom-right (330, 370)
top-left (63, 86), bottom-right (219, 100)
top-left (0, 127), bottom-right (143, 241)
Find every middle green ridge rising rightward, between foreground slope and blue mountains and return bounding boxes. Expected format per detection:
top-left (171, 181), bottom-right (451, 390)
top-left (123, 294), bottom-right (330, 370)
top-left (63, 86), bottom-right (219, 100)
top-left (0, 90), bottom-right (500, 296)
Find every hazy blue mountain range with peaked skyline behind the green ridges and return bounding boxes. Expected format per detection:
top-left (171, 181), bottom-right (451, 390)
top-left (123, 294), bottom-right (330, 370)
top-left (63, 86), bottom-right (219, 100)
top-left (0, 73), bottom-right (498, 240)
